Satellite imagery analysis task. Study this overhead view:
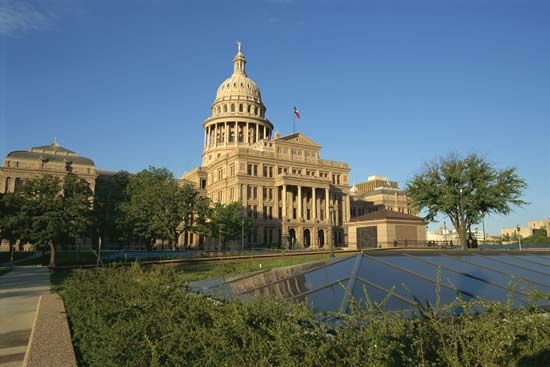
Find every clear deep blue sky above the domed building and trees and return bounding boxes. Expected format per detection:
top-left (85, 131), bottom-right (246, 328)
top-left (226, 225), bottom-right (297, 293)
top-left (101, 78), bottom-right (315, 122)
top-left (0, 0), bottom-right (550, 233)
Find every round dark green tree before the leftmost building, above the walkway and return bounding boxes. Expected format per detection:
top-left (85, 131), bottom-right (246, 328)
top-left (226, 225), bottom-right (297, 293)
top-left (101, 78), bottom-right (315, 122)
top-left (20, 174), bottom-right (92, 266)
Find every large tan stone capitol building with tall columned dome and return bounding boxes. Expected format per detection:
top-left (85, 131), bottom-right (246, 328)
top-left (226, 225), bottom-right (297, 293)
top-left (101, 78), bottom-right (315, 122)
top-left (180, 46), bottom-right (351, 248)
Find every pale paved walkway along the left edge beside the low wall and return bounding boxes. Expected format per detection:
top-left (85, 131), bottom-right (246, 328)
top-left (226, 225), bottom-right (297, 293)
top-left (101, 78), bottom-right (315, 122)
top-left (0, 267), bottom-right (50, 367)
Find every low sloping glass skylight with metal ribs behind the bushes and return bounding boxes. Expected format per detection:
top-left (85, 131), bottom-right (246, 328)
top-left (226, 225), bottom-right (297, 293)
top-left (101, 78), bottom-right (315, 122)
top-left (189, 253), bottom-right (550, 312)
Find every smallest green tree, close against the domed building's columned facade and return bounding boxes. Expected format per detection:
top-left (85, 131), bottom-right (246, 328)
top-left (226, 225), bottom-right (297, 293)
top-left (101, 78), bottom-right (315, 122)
top-left (209, 202), bottom-right (254, 250)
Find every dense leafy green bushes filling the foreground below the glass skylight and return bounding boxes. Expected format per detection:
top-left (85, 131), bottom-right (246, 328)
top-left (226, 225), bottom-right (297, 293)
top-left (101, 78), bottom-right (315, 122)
top-left (61, 266), bottom-right (550, 367)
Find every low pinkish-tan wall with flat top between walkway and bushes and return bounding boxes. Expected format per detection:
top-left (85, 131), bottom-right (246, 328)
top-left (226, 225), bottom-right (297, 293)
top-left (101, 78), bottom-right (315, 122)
top-left (23, 294), bottom-right (77, 367)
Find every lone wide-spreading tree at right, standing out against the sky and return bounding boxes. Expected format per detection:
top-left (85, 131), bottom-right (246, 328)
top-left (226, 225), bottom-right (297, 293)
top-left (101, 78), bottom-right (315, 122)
top-left (406, 153), bottom-right (527, 249)
